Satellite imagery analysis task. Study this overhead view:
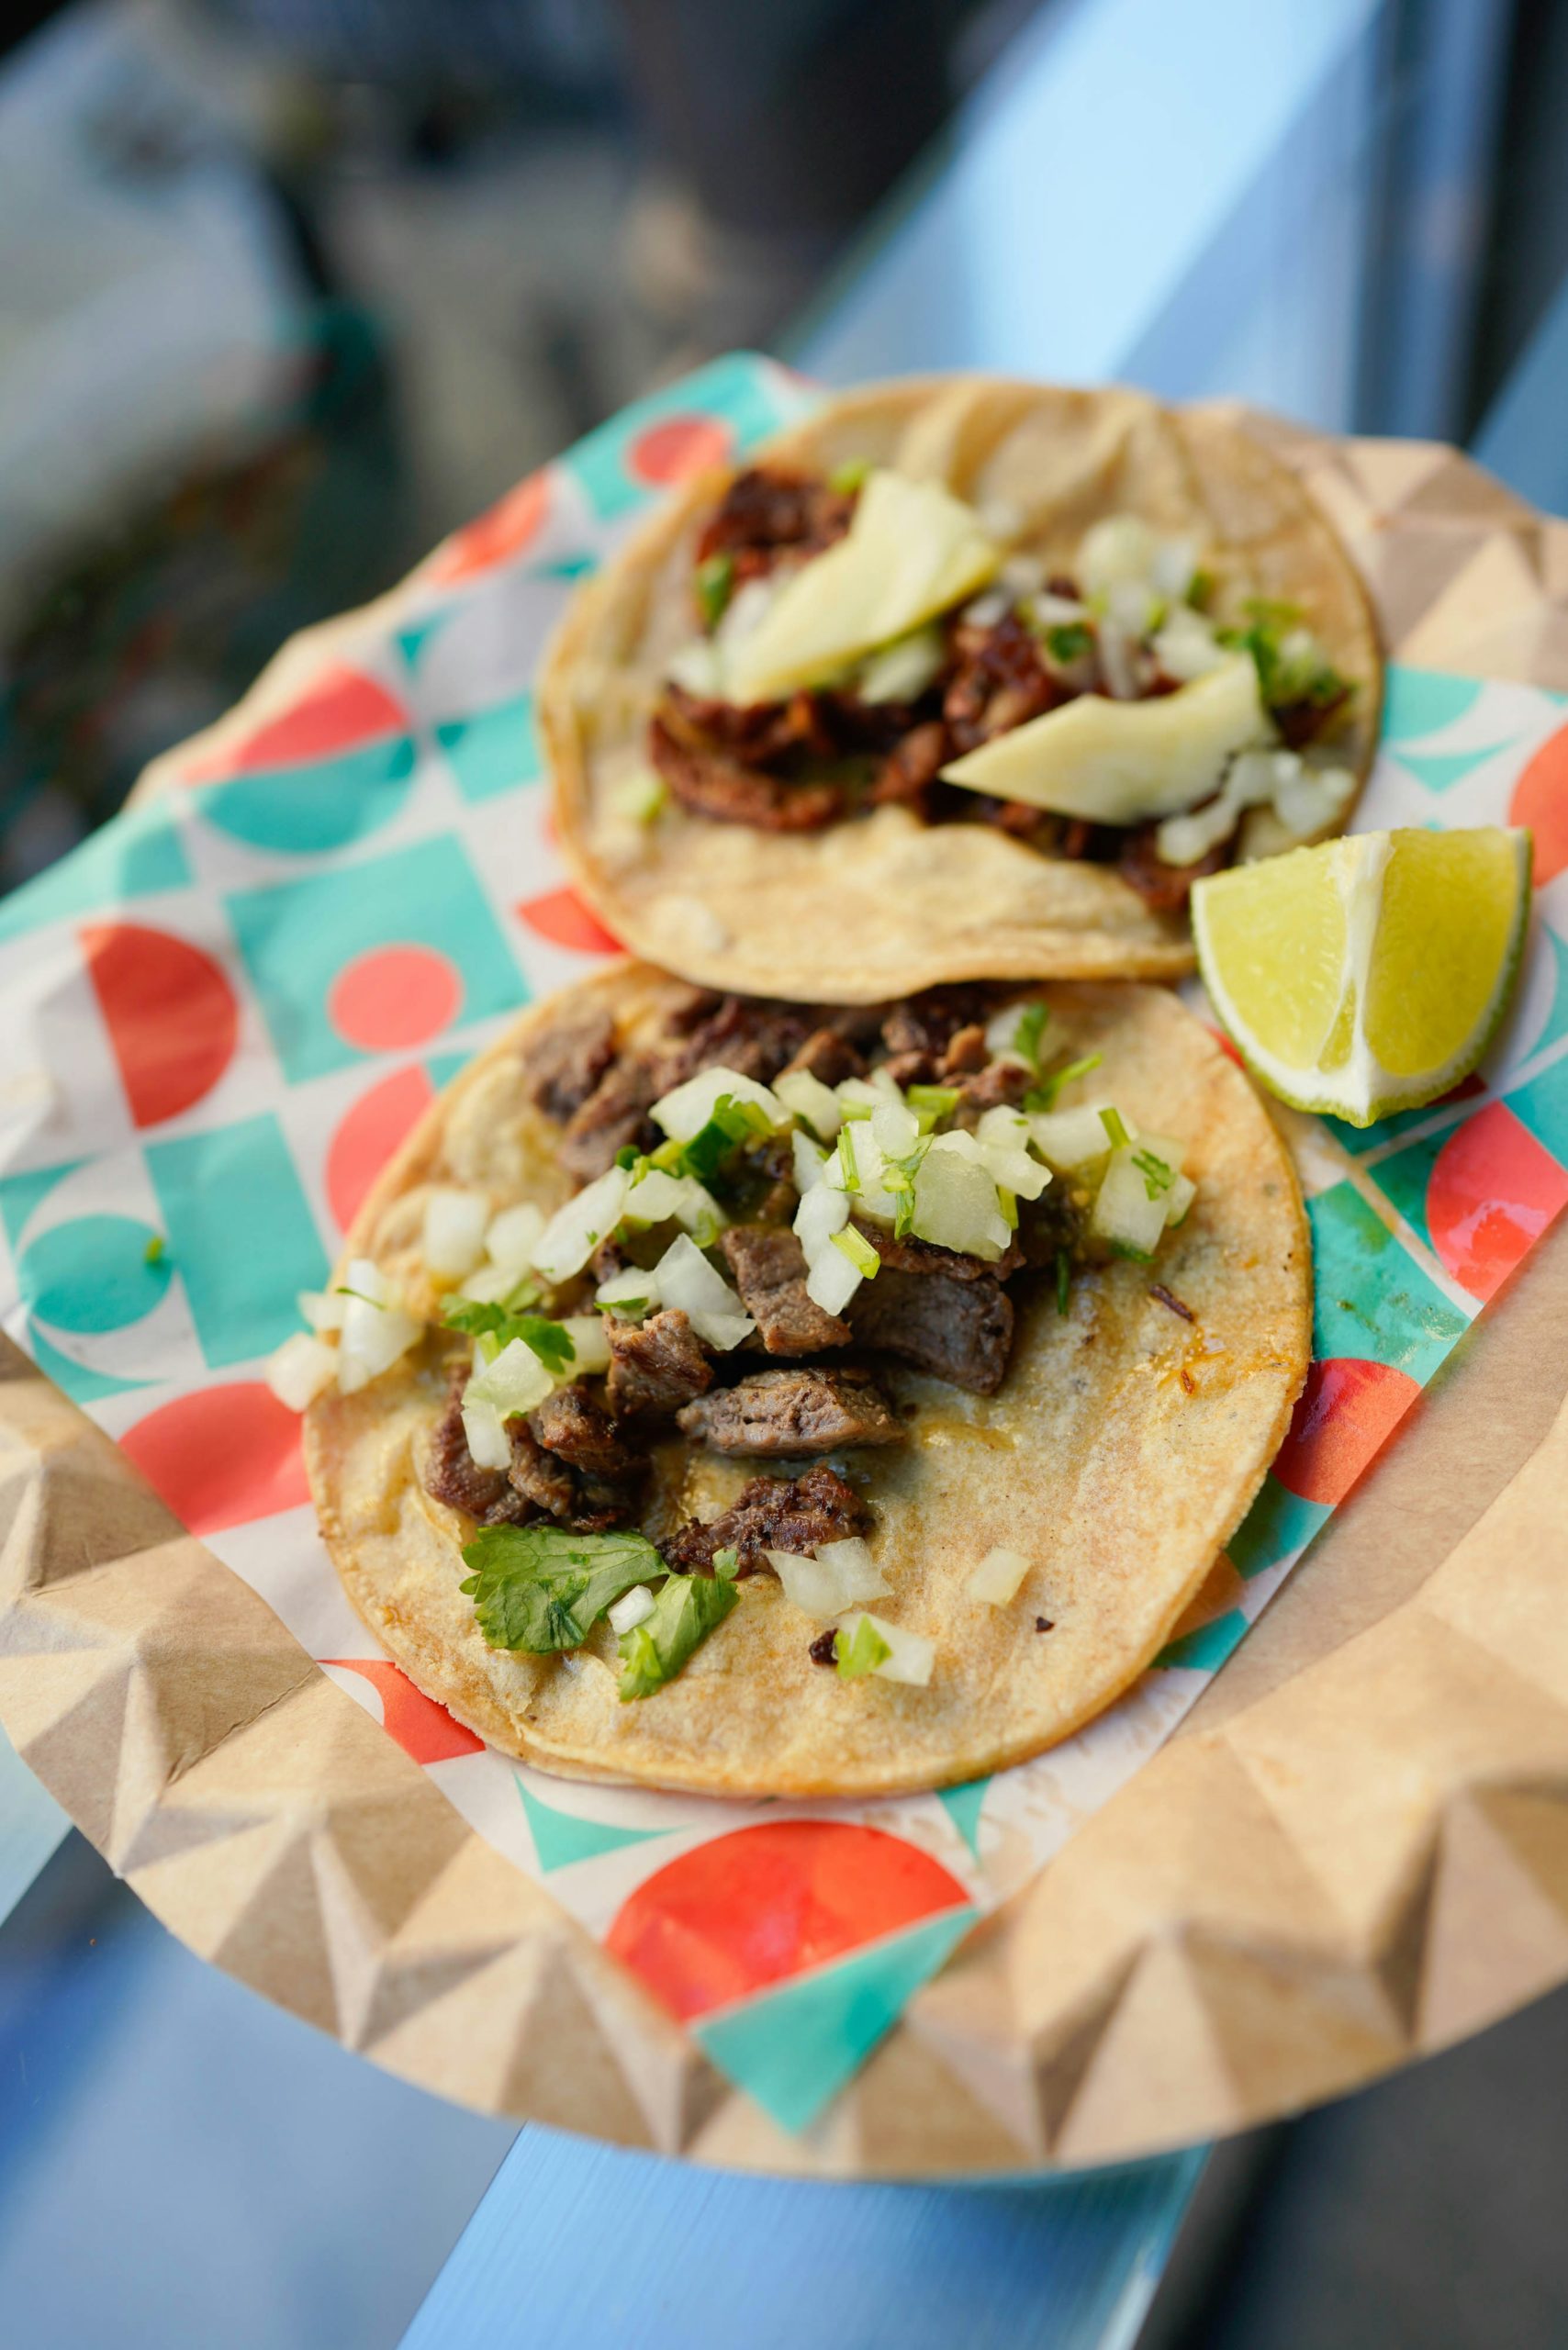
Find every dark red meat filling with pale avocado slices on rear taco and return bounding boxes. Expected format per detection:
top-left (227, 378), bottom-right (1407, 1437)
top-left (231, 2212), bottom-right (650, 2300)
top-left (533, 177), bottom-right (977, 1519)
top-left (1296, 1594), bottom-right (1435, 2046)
top-left (640, 465), bottom-right (1359, 912)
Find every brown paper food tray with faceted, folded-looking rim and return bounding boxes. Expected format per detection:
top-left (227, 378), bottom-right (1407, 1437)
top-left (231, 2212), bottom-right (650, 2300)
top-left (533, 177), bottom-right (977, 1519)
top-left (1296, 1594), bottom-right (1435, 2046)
top-left (0, 416), bottom-right (1568, 2177)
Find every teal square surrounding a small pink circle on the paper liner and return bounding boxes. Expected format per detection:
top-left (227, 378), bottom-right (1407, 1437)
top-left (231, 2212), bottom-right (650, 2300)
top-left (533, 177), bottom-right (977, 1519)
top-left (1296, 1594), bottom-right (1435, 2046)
top-left (226, 834), bottom-right (529, 1086)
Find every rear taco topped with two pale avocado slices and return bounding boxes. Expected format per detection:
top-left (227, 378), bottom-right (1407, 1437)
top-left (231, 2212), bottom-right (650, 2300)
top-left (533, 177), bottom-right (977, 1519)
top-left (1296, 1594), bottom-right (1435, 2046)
top-left (538, 376), bottom-right (1383, 1002)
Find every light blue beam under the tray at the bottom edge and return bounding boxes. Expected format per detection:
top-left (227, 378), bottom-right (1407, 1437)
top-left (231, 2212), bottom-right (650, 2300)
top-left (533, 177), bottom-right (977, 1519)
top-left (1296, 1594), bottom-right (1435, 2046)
top-left (402, 2129), bottom-right (1204, 2350)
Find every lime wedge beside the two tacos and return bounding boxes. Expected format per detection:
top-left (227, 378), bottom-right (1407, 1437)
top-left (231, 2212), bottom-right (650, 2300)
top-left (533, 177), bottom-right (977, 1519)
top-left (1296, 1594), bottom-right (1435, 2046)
top-left (1192, 827), bottom-right (1530, 1125)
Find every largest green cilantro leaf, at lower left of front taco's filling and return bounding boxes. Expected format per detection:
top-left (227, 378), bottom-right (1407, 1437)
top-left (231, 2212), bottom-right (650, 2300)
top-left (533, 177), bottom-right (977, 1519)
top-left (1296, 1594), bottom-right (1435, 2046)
top-left (458, 1525), bottom-right (666, 1657)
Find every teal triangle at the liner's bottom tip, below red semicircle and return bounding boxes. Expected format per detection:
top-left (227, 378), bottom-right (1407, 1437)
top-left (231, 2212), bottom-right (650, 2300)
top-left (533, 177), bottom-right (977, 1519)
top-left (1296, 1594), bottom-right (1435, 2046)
top-left (691, 1904), bottom-right (976, 2132)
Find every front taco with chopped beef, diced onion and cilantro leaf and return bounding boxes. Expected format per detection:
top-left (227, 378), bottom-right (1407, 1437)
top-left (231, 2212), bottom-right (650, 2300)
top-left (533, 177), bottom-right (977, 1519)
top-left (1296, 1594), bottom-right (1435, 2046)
top-left (291, 966), bottom-right (1309, 1796)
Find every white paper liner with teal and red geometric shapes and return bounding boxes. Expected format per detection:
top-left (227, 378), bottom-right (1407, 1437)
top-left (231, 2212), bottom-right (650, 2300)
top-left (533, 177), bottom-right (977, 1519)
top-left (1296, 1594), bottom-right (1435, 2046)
top-left (0, 360), bottom-right (1568, 2132)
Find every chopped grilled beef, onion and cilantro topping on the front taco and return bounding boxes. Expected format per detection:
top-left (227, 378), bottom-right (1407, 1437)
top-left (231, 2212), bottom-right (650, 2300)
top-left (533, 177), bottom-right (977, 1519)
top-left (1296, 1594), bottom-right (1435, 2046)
top-left (287, 968), bottom-right (1260, 1704)
